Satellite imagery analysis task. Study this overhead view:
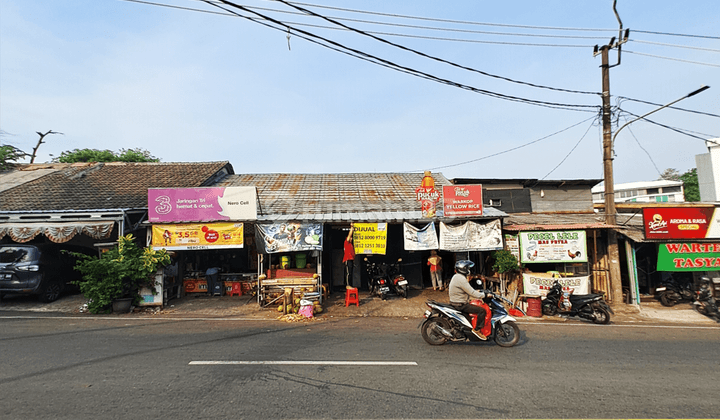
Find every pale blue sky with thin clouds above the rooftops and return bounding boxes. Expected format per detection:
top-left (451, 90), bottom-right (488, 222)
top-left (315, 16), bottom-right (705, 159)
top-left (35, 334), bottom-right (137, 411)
top-left (0, 0), bottom-right (720, 183)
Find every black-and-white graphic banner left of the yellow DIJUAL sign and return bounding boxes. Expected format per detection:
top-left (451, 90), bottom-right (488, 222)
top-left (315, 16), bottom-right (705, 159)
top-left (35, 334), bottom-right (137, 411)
top-left (255, 222), bottom-right (323, 254)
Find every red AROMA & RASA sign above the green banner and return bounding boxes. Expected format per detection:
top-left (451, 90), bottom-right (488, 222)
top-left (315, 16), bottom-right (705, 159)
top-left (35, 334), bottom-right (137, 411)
top-left (643, 207), bottom-right (720, 239)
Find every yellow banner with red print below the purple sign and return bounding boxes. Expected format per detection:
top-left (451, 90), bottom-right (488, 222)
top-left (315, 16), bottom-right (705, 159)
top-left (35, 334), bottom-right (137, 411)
top-left (151, 222), bottom-right (244, 250)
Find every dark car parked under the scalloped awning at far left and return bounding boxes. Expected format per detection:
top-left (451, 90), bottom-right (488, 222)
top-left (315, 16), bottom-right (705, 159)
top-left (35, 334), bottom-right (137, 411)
top-left (0, 244), bottom-right (94, 302)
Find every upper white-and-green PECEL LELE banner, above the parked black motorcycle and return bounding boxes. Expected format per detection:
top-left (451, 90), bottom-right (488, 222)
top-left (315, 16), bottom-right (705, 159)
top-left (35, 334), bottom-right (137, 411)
top-left (520, 230), bottom-right (587, 263)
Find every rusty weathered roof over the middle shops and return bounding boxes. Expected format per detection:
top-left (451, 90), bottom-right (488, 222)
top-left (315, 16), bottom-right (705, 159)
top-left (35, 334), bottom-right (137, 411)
top-left (216, 173), bottom-right (506, 222)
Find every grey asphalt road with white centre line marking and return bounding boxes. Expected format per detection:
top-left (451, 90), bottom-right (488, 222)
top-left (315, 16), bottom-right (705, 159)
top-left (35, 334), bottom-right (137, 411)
top-left (0, 312), bottom-right (720, 419)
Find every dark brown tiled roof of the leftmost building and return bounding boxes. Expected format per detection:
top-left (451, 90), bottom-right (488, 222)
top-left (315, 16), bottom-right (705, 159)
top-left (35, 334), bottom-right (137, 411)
top-left (0, 161), bottom-right (233, 211)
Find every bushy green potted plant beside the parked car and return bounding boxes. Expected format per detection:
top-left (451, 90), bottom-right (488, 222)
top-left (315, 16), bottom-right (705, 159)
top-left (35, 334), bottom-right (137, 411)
top-left (75, 234), bottom-right (170, 313)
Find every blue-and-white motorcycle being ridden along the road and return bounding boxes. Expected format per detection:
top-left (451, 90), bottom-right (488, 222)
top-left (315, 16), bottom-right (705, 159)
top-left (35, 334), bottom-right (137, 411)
top-left (418, 291), bottom-right (520, 347)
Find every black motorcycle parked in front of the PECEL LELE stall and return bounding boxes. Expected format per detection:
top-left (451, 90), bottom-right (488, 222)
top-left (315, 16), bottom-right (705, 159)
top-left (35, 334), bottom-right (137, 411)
top-left (542, 280), bottom-right (615, 324)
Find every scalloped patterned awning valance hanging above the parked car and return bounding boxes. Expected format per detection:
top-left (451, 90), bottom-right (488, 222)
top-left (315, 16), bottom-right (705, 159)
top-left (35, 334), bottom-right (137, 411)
top-left (0, 221), bottom-right (115, 243)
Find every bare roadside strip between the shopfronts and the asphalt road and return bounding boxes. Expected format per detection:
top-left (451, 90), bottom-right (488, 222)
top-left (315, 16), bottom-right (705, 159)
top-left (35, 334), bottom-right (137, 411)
top-left (0, 289), bottom-right (720, 326)
